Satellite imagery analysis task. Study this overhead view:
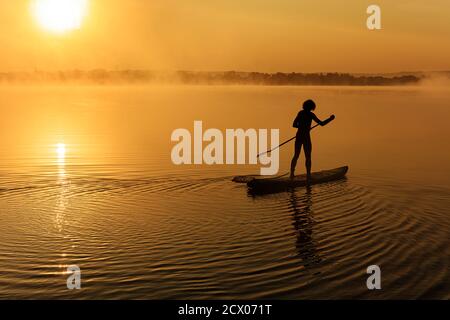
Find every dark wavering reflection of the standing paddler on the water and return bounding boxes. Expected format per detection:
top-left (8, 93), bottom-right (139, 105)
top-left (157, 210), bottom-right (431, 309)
top-left (290, 187), bottom-right (321, 267)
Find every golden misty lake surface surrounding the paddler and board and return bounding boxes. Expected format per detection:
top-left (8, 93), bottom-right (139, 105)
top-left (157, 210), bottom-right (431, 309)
top-left (0, 86), bottom-right (450, 299)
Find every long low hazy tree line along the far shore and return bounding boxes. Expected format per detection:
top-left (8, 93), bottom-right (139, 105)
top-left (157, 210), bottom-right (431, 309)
top-left (0, 69), bottom-right (422, 86)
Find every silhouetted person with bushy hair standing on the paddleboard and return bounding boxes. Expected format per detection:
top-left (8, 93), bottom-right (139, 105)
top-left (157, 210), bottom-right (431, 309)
top-left (290, 100), bottom-right (336, 182)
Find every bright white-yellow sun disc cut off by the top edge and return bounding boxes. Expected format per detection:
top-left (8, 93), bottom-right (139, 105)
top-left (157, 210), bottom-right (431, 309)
top-left (31, 0), bottom-right (88, 33)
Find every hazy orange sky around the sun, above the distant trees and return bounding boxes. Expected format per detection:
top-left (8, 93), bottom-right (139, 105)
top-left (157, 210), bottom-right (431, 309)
top-left (0, 0), bottom-right (450, 72)
